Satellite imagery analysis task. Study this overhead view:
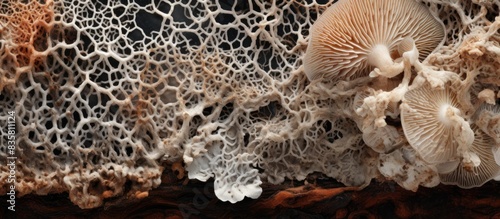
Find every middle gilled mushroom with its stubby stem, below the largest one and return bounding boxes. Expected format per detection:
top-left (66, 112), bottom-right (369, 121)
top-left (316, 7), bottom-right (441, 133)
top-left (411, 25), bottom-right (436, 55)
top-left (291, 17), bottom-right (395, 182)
top-left (400, 83), bottom-right (474, 164)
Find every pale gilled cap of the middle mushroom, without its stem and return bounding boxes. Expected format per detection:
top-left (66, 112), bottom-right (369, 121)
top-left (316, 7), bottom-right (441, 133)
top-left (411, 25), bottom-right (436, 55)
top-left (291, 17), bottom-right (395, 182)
top-left (400, 83), bottom-right (473, 164)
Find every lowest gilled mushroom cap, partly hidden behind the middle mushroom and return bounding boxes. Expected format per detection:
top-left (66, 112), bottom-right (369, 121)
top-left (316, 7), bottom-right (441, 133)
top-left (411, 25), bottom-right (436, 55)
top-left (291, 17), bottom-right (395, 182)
top-left (440, 127), bottom-right (500, 188)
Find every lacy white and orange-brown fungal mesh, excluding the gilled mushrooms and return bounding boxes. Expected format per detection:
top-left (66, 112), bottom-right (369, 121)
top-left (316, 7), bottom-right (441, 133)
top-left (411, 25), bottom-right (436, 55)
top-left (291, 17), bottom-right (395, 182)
top-left (0, 0), bottom-right (500, 208)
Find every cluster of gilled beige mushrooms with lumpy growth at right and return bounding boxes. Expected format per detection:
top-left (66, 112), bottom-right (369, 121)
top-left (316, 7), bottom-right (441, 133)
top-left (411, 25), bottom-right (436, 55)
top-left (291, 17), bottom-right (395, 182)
top-left (304, 0), bottom-right (500, 190)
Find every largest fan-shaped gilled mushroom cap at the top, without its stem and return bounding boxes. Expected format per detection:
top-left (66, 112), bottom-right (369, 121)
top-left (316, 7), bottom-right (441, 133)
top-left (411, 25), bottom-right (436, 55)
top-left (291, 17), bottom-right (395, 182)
top-left (304, 0), bottom-right (445, 81)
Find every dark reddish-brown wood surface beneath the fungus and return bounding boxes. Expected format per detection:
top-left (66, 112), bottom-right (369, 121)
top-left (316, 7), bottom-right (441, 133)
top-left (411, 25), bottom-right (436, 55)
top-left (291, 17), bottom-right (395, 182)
top-left (0, 169), bottom-right (500, 219)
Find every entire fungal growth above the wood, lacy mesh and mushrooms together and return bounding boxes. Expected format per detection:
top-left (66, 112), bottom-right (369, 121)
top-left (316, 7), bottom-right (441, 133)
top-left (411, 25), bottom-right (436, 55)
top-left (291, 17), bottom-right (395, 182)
top-left (0, 0), bottom-right (500, 208)
